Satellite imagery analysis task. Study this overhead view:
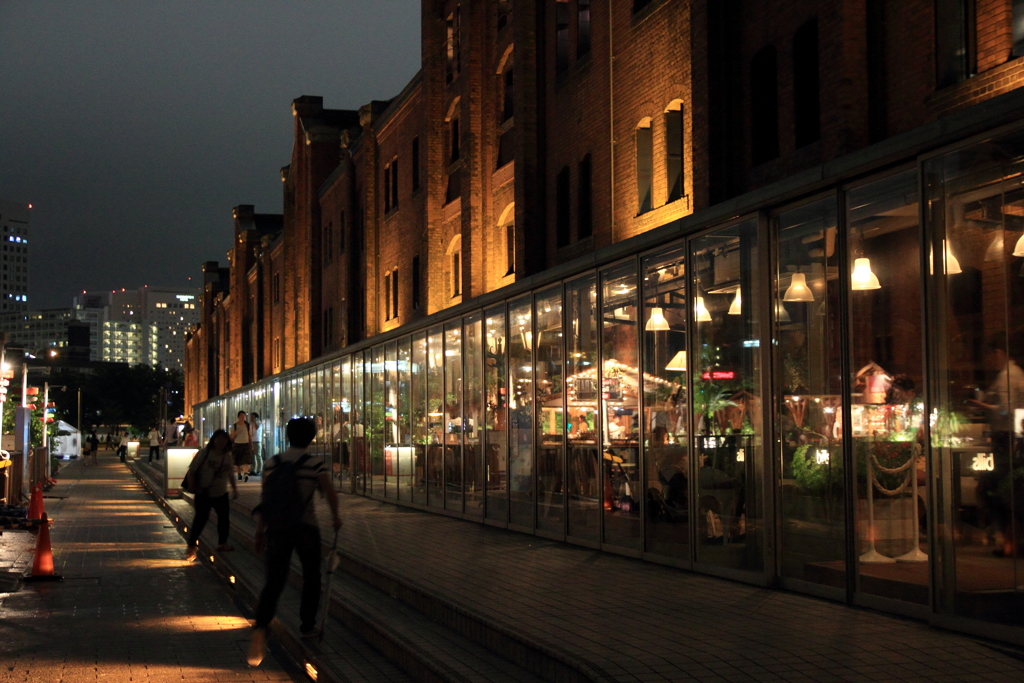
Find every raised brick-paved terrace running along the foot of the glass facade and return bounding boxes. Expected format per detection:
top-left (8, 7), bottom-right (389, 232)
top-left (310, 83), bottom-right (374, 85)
top-left (211, 482), bottom-right (1024, 682)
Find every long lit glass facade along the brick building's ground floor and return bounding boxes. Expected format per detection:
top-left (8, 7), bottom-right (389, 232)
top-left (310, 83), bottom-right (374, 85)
top-left (194, 129), bottom-right (1024, 637)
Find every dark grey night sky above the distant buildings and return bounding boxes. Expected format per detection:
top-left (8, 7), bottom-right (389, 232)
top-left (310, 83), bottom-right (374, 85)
top-left (0, 0), bottom-right (420, 309)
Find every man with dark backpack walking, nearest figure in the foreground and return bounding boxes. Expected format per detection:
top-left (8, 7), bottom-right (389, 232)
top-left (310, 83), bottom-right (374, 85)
top-left (248, 418), bottom-right (342, 667)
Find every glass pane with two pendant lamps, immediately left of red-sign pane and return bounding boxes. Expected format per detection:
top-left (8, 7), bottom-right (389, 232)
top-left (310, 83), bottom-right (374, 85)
top-left (642, 246), bottom-right (690, 558)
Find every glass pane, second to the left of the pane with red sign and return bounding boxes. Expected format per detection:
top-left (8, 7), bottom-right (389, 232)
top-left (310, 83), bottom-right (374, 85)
top-left (601, 262), bottom-right (642, 550)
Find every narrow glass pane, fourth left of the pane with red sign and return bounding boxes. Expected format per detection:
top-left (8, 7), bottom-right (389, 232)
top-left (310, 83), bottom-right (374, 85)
top-left (534, 286), bottom-right (565, 533)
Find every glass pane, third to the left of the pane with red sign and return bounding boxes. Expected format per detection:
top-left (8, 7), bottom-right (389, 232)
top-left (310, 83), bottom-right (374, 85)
top-left (564, 275), bottom-right (601, 542)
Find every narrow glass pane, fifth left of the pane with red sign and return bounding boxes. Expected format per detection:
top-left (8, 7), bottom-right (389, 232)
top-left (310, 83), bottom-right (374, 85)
top-left (509, 296), bottom-right (534, 528)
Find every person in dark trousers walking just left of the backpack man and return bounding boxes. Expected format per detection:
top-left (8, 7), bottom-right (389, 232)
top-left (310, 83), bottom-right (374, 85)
top-left (185, 429), bottom-right (239, 562)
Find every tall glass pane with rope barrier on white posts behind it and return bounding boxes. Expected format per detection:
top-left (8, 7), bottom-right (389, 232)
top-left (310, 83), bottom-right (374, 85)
top-left (847, 171), bottom-right (929, 604)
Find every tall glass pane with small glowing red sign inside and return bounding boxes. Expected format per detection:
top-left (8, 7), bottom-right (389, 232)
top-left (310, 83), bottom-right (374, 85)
top-left (692, 220), bottom-right (765, 570)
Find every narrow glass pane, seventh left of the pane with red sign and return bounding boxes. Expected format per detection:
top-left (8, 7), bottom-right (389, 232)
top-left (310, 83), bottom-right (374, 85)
top-left (463, 313), bottom-right (484, 517)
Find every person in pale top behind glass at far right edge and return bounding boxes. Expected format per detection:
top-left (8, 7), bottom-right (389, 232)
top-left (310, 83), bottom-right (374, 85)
top-left (970, 333), bottom-right (1024, 557)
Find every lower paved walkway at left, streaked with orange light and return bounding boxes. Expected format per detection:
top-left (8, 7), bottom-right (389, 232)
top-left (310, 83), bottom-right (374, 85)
top-left (0, 455), bottom-right (293, 683)
